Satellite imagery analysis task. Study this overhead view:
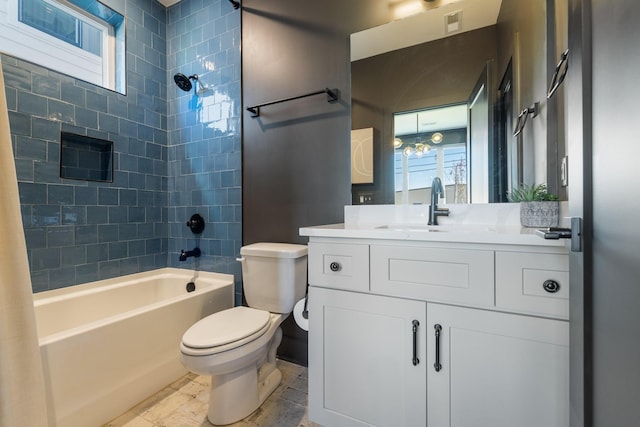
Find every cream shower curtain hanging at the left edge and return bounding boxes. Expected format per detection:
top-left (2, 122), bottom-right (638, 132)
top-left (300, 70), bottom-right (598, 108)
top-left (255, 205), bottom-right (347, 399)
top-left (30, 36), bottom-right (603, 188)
top-left (0, 62), bottom-right (47, 427)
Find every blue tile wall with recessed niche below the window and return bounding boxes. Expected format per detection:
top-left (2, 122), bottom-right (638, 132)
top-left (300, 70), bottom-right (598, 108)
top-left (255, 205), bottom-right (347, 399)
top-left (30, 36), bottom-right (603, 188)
top-left (2, 0), bottom-right (168, 292)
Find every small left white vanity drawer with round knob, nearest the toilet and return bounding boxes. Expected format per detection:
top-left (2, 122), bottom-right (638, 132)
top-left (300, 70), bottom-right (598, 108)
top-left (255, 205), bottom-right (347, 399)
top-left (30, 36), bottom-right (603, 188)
top-left (308, 242), bottom-right (369, 292)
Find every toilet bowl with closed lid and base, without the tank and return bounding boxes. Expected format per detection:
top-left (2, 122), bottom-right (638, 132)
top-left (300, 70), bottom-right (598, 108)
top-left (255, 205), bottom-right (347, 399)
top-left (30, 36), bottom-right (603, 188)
top-left (180, 306), bottom-right (287, 425)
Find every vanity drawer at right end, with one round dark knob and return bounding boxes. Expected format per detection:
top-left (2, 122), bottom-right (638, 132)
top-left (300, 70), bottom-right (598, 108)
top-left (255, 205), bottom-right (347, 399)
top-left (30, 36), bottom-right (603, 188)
top-left (496, 251), bottom-right (569, 319)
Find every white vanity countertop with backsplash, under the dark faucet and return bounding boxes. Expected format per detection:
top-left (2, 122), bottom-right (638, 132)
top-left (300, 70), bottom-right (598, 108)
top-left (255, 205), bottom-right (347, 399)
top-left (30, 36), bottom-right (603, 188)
top-left (300, 203), bottom-right (565, 247)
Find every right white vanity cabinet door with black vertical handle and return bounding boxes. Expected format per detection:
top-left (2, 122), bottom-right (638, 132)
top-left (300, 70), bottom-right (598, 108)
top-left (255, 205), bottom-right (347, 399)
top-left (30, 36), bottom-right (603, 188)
top-left (427, 304), bottom-right (569, 427)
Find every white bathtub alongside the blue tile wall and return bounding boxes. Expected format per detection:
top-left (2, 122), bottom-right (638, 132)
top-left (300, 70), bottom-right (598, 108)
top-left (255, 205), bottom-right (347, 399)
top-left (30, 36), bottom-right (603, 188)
top-left (34, 268), bottom-right (234, 427)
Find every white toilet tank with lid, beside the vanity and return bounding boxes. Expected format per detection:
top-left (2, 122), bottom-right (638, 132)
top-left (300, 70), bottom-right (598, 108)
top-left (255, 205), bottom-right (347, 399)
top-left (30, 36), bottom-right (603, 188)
top-left (240, 243), bottom-right (307, 313)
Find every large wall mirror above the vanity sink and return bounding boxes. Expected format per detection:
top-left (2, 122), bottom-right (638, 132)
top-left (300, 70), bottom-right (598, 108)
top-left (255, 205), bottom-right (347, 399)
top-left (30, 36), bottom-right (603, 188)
top-left (351, 0), bottom-right (560, 204)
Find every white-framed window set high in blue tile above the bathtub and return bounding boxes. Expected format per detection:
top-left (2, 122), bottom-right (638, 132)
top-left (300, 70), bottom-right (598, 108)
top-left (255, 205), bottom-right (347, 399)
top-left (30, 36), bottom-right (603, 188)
top-left (0, 0), bottom-right (126, 94)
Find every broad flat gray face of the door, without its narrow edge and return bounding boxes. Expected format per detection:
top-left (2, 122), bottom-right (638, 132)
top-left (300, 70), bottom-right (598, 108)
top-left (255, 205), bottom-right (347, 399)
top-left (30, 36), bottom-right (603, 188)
top-left (583, 0), bottom-right (640, 426)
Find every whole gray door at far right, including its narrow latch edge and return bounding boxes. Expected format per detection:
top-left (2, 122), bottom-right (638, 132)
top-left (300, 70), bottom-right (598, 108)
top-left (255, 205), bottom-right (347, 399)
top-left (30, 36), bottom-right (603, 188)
top-left (567, 0), bottom-right (640, 426)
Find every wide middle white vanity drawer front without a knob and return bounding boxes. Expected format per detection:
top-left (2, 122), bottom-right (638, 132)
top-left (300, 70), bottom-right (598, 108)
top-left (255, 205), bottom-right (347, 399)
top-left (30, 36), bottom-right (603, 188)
top-left (370, 245), bottom-right (494, 306)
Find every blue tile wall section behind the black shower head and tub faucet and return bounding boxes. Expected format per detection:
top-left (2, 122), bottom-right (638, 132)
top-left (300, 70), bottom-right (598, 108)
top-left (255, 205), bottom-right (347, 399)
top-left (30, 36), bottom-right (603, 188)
top-left (166, 0), bottom-right (242, 302)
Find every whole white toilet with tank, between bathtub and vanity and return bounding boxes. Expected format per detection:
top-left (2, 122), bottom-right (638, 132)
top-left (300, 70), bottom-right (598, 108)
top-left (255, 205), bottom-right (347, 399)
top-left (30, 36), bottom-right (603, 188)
top-left (180, 243), bottom-right (307, 425)
